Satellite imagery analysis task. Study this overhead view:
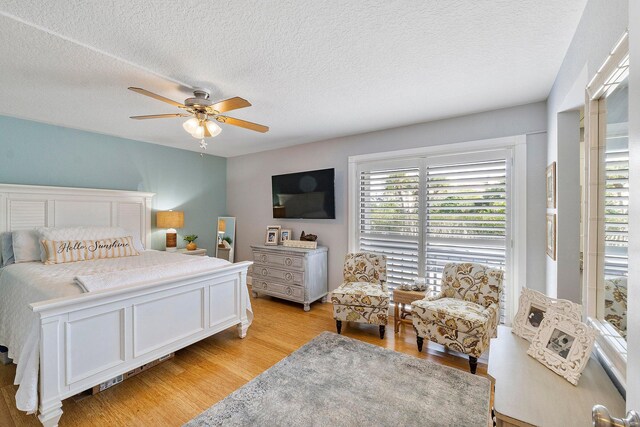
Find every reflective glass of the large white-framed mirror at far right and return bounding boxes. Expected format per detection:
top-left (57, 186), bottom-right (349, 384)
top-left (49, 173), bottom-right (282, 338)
top-left (597, 72), bottom-right (629, 339)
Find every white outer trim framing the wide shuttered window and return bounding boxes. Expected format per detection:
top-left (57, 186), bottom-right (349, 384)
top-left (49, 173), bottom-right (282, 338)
top-left (347, 135), bottom-right (527, 325)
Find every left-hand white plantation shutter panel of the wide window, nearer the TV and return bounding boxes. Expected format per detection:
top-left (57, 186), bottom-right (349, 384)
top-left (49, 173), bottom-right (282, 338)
top-left (358, 162), bottom-right (421, 289)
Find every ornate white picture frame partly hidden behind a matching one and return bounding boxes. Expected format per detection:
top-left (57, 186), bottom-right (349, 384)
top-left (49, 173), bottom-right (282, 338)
top-left (511, 288), bottom-right (582, 341)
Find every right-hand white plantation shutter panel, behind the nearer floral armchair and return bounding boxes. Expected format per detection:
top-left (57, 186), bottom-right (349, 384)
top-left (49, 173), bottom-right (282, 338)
top-left (424, 153), bottom-right (509, 318)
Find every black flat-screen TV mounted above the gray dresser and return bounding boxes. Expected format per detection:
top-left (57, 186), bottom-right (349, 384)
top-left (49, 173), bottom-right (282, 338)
top-left (271, 169), bottom-right (336, 219)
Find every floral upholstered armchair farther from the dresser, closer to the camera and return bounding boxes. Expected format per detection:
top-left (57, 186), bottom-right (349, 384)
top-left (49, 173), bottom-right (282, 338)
top-left (411, 263), bottom-right (504, 374)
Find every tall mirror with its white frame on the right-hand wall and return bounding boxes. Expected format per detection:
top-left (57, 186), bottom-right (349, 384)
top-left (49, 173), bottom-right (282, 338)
top-left (583, 34), bottom-right (629, 384)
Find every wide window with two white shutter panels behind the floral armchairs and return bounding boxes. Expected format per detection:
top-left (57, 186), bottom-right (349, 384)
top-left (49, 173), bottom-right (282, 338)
top-left (350, 138), bottom-right (524, 321)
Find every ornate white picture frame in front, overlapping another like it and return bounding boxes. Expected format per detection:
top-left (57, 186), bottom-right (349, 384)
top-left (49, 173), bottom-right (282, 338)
top-left (527, 311), bottom-right (596, 385)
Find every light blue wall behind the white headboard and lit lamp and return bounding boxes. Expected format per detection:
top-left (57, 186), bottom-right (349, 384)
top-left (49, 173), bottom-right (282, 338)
top-left (0, 116), bottom-right (227, 254)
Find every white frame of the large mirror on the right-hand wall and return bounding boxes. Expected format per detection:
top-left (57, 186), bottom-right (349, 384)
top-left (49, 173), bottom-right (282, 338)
top-left (582, 32), bottom-right (629, 388)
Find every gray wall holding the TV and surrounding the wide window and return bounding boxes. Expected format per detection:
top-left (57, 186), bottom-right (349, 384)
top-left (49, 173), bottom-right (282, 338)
top-left (227, 102), bottom-right (546, 290)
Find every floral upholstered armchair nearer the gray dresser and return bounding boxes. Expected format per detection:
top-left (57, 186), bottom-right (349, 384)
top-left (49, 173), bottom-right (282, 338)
top-left (331, 252), bottom-right (389, 339)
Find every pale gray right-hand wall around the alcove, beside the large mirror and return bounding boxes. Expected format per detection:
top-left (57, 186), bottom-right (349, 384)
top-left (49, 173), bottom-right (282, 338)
top-left (546, 0), bottom-right (628, 302)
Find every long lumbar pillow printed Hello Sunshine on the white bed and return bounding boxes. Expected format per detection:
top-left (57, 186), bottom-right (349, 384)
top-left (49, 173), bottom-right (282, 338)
top-left (42, 236), bottom-right (140, 264)
